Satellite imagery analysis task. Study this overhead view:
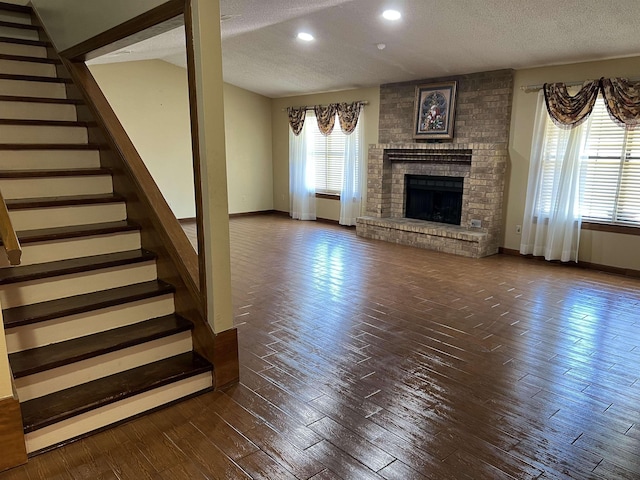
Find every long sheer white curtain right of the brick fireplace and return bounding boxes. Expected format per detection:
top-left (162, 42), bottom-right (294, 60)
top-left (520, 92), bottom-right (590, 262)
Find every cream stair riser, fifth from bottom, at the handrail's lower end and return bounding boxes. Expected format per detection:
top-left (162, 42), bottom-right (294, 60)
top-left (0, 231), bottom-right (140, 267)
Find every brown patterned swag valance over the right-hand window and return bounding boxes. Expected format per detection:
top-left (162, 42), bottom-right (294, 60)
top-left (543, 78), bottom-right (640, 129)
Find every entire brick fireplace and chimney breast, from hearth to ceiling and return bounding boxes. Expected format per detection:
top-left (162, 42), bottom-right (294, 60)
top-left (356, 70), bottom-right (513, 258)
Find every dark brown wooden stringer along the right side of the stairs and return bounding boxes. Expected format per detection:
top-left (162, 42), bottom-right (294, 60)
top-left (51, 53), bottom-right (239, 388)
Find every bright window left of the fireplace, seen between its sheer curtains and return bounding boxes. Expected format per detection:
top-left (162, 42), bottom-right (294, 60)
top-left (305, 112), bottom-right (361, 195)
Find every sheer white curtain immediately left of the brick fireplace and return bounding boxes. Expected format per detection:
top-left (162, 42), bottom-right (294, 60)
top-left (339, 119), bottom-right (363, 225)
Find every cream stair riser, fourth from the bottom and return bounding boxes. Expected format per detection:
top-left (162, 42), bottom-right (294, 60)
top-left (0, 262), bottom-right (157, 308)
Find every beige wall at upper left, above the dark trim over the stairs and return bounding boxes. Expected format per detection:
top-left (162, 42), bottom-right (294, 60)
top-left (31, 0), bottom-right (167, 51)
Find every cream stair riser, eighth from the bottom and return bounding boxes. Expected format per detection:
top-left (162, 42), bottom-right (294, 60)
top-left (0, 150), bottom-right (100, 170)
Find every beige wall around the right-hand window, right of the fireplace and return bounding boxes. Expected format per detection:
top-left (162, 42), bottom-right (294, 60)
top-left (503, 57), bottom-right (640, 270)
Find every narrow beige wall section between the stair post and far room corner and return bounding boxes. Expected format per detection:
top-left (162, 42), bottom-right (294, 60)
top-left (224, 84), bottom-right (273, 213)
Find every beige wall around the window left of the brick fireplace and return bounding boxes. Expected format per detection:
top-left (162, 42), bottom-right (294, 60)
top-left (271, 87), bottom-right (380, 221)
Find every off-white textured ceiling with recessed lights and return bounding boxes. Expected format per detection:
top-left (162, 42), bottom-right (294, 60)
top-left (87, 0), bottom-right (640, 98)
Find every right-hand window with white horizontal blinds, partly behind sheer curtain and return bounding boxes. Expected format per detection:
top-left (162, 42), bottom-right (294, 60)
top-left (537, 97), bottom-right (640, 226)
